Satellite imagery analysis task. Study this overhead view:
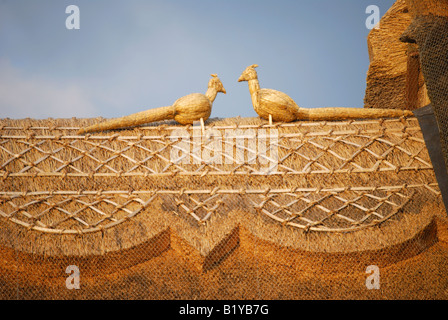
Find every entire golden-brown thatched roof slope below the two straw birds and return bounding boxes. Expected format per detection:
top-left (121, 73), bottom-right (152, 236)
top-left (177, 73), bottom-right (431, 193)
top-left (0, 117), bottom-right (448, 299)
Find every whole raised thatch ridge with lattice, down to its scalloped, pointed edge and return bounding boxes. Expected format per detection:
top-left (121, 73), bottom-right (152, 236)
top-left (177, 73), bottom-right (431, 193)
top-left (0, 117), bottom-right (443, 257)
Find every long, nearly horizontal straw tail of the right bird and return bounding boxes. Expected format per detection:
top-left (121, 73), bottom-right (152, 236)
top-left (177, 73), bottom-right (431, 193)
top-left (297, 107), bottom-right (414, 121)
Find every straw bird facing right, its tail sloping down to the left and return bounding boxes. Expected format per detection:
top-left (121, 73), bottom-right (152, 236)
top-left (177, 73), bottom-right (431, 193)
top-left (78, 74), bottom-right (226, 134)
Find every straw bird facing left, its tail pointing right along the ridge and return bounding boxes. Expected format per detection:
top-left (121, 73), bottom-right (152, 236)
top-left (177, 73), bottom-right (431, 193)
top-left (238, 64), bottom-right (413, 123)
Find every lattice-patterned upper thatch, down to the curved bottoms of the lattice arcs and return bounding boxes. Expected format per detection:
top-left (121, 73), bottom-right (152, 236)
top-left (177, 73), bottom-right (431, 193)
top-left (0, 118), bottom-right (439, 251)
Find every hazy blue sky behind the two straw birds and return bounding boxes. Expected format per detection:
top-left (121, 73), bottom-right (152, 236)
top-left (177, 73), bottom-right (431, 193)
top-left (0, 0), bottom-right (394, 118)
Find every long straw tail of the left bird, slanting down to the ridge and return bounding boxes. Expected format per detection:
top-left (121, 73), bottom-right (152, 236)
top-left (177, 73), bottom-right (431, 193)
top-left (78, 106), bottom-right (175, 134)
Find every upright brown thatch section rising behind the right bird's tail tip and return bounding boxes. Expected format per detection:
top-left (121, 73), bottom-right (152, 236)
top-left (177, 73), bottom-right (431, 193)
top-left (364, 0), bottom-right (429, 110)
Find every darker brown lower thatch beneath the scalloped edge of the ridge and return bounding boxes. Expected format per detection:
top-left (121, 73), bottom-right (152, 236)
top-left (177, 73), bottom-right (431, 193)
top-left (0, 212), bottom-right (448, 298)
